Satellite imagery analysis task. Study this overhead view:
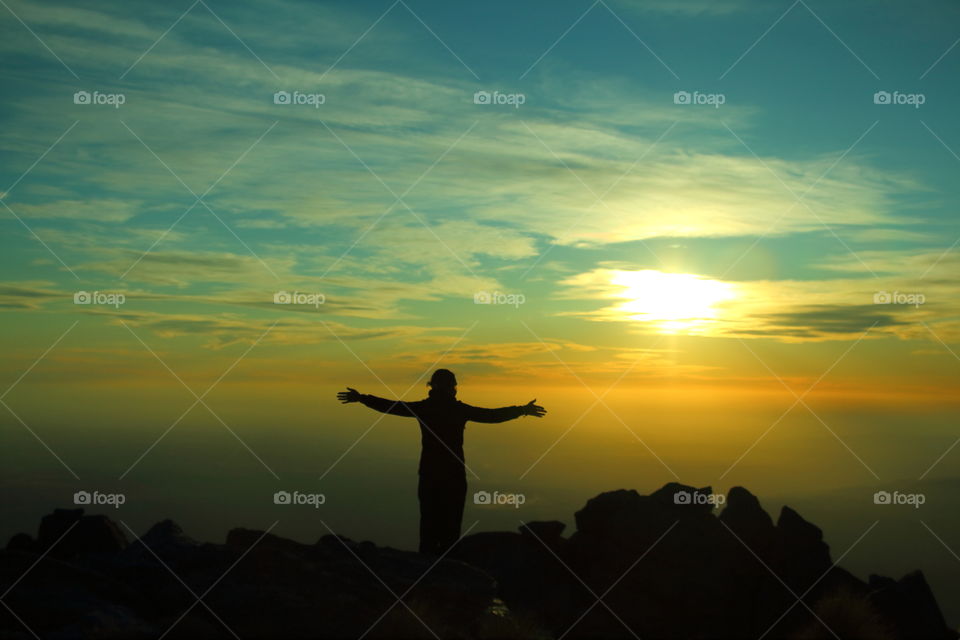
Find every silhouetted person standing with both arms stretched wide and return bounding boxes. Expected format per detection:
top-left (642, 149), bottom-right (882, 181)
top-left (337, 369), bottom-right (546, 555)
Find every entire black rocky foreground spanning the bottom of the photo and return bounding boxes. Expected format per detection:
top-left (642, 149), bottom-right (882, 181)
top-left (0, 484), bottom-right (958, 640)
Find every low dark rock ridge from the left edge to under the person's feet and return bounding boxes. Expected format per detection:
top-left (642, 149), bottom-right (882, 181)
top-left (0, 510), bottom-right (512, 640)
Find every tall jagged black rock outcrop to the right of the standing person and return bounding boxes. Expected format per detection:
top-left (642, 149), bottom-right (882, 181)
top-left (454, 483), bottom-right (957, 640)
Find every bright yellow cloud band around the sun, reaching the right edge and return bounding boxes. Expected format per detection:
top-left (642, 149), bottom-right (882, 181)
top-left (558, 268), bottom-right (960, 342)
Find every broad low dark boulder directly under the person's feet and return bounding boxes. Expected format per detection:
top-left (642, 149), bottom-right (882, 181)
top-left (217, 529), bottom-right (496, 638)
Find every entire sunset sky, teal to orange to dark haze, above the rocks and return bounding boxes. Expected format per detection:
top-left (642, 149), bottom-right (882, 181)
top-left (0, 0), bottom-right (960, 632)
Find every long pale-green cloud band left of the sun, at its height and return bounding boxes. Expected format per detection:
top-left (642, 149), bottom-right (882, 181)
top-left (66, 241), bottom-right (512, 319)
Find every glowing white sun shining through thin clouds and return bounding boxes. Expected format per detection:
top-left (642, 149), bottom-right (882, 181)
top-left (610, 269), bottom-right (736, 333)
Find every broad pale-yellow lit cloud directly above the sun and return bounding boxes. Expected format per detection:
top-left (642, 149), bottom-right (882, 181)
top-left (462, 124), bottom-right (907, 246)
